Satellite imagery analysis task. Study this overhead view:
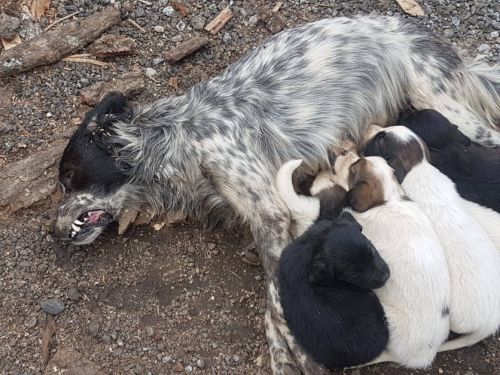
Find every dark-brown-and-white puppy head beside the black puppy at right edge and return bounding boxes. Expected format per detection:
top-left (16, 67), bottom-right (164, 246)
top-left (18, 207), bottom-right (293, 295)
top-left (364, 125), bottom-right (429, 183)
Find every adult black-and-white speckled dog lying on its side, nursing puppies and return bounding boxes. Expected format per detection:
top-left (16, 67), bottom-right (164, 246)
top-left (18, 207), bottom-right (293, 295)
top-left (54, 16), bottom-right (500, 373)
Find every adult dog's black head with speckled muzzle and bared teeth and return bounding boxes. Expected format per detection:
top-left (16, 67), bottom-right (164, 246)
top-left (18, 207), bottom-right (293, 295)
top-left (53, 94), bottom-right (131, 245)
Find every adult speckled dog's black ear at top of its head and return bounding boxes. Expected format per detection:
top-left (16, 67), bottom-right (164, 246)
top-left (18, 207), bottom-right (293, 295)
top-left (86, 92), bottom-right (132, 134)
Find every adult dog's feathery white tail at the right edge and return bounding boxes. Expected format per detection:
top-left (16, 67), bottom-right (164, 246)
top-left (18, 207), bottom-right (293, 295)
top-left (460, 59), bottom-right (500, 129)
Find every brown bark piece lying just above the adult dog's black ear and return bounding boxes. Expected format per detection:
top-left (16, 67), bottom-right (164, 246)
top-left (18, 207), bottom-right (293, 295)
top-left (80, 72), bottom-right (145, 105)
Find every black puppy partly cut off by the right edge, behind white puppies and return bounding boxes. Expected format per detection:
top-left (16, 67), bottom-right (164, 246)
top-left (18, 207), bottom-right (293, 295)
top-left (398, 109), bottom-right (500, 212)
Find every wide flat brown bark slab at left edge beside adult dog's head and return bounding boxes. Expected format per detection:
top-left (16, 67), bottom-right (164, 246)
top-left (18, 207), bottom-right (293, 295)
top-left (0, 141), bottom-right (67, 211)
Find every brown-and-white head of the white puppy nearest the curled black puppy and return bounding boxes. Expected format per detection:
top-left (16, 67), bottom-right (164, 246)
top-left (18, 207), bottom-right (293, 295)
top-left (346, 156), bottom-right (403, 212)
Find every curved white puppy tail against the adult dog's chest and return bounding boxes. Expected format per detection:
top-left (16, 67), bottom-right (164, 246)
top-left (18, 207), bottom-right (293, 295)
top-left (276, 160), bottom-right (319, 236)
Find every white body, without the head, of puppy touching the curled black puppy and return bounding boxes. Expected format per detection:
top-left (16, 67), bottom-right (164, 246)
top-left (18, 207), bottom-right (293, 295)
top-left (353, 201), bottom-right (450, 368)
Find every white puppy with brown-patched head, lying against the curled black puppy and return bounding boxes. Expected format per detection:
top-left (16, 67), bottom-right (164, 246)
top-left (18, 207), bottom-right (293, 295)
top-left (334, 155), bottom-right (450, 368)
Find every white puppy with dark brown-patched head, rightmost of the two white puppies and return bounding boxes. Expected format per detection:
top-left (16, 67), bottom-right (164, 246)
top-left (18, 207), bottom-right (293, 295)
top-left (365, 126), bottom-right (500, 351)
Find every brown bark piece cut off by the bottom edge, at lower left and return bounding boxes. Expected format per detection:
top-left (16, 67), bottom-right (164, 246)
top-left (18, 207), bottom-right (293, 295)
top-left (43, 348), bottom-right (104, 375)
